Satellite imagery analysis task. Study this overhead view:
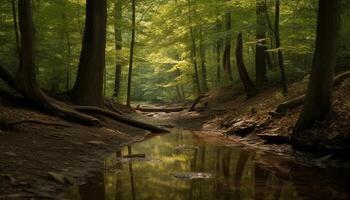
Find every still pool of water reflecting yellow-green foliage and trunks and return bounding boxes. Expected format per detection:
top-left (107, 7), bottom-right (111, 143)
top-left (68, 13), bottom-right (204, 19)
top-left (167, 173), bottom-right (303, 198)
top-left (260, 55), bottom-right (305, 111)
top-left (67, 130), bottom-right (349, 200)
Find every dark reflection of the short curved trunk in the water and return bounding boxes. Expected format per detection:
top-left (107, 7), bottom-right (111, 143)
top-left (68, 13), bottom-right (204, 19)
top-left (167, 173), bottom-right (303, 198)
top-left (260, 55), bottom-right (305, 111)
top-left (234, 151), bottom-right (249, 199)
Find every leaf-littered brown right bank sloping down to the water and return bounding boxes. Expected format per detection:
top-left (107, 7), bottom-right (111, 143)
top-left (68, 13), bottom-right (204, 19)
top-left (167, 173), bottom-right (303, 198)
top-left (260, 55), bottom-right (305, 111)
top-left (161, 78), bottom-right (350, 163)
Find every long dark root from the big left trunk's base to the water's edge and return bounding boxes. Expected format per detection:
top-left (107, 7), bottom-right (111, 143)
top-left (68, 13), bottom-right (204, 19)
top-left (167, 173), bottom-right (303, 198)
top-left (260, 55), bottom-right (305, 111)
top-left (73, 106), bottom-right (169, 133)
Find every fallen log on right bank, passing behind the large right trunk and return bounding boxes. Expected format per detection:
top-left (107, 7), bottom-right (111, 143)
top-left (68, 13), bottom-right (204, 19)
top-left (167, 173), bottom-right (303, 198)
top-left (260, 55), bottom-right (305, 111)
top-left (275, 71), bottom-right (350, 113)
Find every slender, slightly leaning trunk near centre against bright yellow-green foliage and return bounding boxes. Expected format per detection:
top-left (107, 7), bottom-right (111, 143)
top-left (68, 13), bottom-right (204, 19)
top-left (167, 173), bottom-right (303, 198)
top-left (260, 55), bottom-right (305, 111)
top-left (187, 0), bottom-right (202, 95)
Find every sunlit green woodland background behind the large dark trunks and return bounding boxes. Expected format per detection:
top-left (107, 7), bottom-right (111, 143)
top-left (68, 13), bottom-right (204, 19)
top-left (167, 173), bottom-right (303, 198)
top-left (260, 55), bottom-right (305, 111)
top-left (0, 0), bottom-right (350, 102)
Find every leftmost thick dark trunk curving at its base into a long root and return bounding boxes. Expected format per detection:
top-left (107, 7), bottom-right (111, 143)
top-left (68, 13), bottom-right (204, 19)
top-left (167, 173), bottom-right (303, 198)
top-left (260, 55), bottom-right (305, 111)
top-left (14, 0), bottom-right (98, 124)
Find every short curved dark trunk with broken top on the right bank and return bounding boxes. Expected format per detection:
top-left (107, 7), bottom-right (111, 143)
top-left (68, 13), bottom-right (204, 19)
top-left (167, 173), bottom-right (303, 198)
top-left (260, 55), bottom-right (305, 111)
top-left (236, 33), bottom-right (256, 98)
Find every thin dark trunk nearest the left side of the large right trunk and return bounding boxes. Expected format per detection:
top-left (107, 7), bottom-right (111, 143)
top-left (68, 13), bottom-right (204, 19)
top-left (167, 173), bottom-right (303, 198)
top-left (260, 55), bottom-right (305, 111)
top-left (275, 0), bottom-right (288, 95)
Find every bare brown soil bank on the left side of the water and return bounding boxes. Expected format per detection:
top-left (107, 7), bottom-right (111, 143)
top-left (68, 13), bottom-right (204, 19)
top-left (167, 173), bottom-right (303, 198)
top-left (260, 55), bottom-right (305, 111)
top-left (0, 94), bottom-right (159, 199)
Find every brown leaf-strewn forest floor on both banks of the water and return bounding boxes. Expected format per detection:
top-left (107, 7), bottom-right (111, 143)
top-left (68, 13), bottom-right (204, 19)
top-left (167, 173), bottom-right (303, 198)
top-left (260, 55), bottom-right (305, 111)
top-left (0, 76), bottom-right (350, 199)
